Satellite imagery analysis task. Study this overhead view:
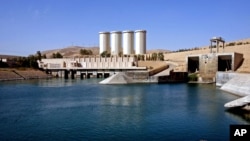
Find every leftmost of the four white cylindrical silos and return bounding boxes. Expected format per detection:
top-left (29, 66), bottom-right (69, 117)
top-left (99, 32), bottom-right (110, 54)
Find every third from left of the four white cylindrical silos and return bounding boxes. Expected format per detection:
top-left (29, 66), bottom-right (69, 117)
top-left (122, 30), bottom-right (134, 55)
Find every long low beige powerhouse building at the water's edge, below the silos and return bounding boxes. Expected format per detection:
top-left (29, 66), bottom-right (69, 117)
top-left (38, 57), bottom-right (147, 79)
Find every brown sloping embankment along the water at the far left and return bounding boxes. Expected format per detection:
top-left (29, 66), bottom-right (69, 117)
top-left (0, 69), bottom-right (51, 81)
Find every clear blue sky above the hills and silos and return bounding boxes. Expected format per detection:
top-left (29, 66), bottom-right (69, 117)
top-left (0, 0), bottom-right (250, 56)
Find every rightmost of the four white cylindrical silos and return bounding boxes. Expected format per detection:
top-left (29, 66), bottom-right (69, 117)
top-left (135, 30), bottom-right (147, 54)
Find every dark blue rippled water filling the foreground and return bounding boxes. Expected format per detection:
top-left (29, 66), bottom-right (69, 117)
top-left (0, 79), bottom-right (250, 141)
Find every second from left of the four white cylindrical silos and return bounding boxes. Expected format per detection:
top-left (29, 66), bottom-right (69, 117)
top-left (111, 31), bottom-right (122, 55)
